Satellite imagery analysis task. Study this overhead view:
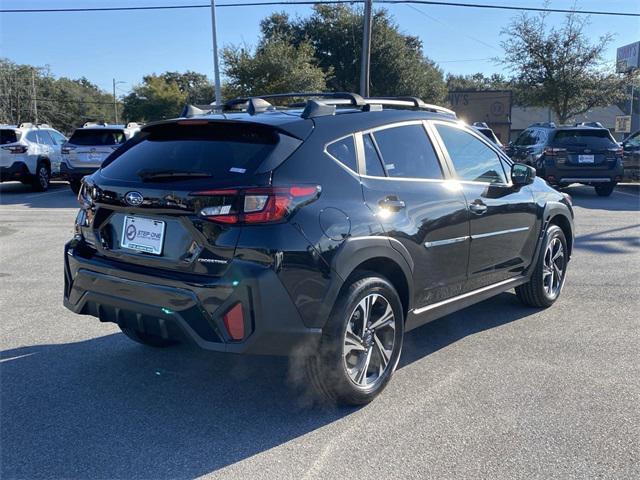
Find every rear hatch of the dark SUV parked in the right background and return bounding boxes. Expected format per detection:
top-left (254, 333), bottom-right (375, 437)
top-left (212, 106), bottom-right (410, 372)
top-left (545, 128), bottom-right (622, 170)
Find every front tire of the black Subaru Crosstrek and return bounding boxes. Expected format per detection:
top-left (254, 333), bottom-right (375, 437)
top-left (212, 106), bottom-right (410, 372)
top-left (516, 225), bottom-right (569, 308)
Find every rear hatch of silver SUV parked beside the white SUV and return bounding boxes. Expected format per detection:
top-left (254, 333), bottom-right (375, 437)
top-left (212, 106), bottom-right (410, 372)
top-left (64, 128), bottom-right (126, 168)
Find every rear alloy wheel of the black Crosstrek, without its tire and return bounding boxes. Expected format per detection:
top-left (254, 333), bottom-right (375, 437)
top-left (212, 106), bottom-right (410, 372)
top-left (343, 293), bottom-right (396, 387)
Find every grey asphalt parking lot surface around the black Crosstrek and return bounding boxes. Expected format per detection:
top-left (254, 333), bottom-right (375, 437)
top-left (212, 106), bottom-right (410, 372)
top-left (0, 183), bottom-right (640, 479)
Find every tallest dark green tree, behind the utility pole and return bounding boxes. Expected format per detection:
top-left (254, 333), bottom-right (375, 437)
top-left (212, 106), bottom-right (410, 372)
top-left (261, 5), bottom-right (446, 103)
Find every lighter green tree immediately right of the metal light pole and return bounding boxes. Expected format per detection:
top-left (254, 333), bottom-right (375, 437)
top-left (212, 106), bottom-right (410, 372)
top-left (222, 36), bottom-right (327, 98)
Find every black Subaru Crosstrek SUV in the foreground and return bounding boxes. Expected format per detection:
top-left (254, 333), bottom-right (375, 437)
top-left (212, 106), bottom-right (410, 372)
top-left (64, 93), bottom-right (574, 404)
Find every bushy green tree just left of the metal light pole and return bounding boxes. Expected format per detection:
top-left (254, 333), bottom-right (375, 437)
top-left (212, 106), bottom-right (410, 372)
top-left (123, 74), bottom-right (189, 122)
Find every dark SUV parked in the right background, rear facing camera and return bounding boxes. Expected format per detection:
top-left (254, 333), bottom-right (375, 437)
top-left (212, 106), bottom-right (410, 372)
top-left (507, 122), bottom-right (624, 197)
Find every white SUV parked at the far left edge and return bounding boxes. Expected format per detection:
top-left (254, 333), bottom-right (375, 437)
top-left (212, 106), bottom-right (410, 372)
top-left (0, 123), bottom-right (66, 192)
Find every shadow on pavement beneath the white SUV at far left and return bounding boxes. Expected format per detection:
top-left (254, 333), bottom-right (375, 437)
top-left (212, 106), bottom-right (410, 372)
top-left (0, 182), bottom-right (78, 208)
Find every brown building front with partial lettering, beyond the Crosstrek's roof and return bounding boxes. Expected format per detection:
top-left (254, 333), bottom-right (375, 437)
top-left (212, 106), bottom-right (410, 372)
top-left (448, 90), bottom-right (511, 143)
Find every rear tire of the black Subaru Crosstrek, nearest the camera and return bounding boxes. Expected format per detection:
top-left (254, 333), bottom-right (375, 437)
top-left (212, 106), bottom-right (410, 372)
top-left (306, 272), bottom-right (404, 405)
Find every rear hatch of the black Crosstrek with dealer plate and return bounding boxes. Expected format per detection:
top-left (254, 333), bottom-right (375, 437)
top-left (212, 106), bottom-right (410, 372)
top-left (81, 120), bottom-right (301, 275)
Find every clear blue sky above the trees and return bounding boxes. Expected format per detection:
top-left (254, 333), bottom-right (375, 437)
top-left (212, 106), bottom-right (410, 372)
top-left (0, 0), bottom-right (640, 96)
